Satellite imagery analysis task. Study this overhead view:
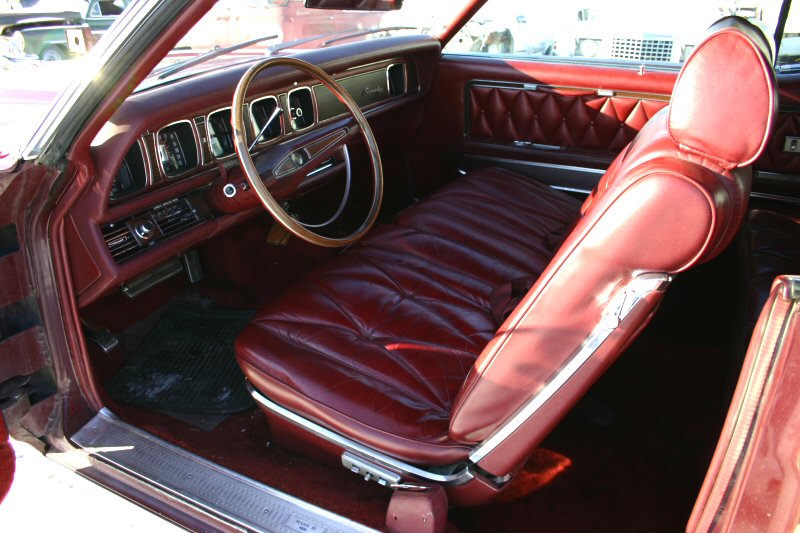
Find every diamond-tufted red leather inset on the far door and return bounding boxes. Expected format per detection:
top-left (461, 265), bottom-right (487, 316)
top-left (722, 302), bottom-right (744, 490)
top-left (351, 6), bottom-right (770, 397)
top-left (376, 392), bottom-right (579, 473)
top-left (469, 85), bottom-right (668, 154)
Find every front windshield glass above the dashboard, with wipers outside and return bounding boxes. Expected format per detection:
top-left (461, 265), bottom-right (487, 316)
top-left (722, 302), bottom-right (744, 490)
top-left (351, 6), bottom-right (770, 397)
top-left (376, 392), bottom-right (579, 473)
top-left (139, 0), bottom-right (467, 90)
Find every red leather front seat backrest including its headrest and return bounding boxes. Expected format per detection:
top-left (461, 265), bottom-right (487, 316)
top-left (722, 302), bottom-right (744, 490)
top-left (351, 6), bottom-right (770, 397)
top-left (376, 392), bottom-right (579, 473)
top-left (450, 17), bottom-right (777, 476)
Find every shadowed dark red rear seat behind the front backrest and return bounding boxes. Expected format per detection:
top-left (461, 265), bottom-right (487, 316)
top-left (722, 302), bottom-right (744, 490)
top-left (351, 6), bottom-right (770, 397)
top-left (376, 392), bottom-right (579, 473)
top-left (747, 209), bottom-right (800, 332)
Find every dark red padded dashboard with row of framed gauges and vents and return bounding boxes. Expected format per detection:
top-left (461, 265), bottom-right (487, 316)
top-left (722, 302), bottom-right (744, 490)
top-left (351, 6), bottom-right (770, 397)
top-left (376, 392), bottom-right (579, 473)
top-left (66, 36), bottom-right (440, 306)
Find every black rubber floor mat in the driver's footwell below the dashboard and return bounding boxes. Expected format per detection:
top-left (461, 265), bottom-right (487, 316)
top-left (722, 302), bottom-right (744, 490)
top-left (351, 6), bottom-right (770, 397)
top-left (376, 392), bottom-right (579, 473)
top-left (106, 302), bottom-right (253, 414)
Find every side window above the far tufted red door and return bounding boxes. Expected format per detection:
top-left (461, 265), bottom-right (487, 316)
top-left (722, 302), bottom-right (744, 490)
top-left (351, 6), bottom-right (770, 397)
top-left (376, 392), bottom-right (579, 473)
top-left (445, 0), bottom-right (784, 65)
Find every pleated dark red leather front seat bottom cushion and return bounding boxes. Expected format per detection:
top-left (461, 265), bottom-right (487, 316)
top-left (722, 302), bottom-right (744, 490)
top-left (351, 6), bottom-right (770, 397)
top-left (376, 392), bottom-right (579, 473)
top-left (236, 168), bottom-right (580, 465)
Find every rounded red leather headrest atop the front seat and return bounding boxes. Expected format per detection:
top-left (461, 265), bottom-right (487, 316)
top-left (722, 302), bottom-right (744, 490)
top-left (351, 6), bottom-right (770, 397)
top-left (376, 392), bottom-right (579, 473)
top-left (669, 17), bottom-right (778, 168)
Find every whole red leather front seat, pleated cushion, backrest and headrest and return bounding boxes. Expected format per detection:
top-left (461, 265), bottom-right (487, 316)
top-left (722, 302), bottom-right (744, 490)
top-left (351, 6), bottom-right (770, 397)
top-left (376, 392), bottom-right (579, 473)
top-left (236, 15), bottom-right (775, 503)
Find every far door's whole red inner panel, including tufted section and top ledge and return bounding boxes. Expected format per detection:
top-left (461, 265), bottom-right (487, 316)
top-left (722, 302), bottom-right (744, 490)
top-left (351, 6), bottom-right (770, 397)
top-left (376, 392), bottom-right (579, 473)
top-left (416, 55), bottom-right (677, 189)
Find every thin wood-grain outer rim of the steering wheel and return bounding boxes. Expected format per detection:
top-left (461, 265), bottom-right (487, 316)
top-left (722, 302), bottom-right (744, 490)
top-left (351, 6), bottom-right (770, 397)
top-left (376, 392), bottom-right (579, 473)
top-left (231, 57), bottom-right (383, 248)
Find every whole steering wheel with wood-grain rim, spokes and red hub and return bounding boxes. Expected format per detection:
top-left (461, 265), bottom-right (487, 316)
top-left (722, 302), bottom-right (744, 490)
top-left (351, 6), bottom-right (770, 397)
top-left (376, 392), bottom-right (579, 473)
top-left (231, 57), bottom-right (383, 248)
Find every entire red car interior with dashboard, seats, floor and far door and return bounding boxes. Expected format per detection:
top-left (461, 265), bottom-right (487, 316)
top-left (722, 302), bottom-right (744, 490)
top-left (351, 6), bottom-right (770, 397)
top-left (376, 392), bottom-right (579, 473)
top-left (10, 2), bottom-right (800, 531)
